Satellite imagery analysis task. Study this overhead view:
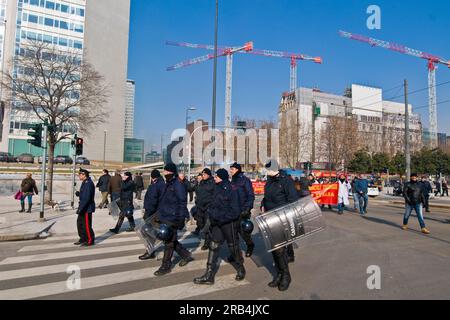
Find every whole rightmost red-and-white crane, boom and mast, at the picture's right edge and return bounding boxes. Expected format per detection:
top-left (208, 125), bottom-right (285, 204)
top-left (339, 31), bottom-right (450, 147)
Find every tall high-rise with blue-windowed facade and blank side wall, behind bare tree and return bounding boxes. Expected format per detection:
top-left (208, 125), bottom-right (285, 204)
top-left (0, 0), bottom-right (130, 161)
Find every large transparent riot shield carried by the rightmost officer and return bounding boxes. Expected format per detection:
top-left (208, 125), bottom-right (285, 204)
top-left (256, 196), bottom-right (325, 252)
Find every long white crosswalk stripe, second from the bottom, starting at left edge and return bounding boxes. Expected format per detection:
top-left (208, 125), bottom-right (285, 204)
top-left (0, 260), bottom-right (214, 300)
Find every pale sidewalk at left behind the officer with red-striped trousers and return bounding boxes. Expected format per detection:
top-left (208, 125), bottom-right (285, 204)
top-left (0, 193), bottom-right (197, 242)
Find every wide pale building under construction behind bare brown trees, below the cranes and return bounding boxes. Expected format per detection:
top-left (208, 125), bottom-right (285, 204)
top-left (278, 85), bottom-right (422, 169)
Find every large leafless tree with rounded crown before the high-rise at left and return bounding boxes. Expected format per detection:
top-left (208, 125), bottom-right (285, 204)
top-left (3, 41), bottom-right (109, 202)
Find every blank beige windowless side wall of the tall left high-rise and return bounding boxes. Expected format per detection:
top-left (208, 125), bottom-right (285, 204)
top-left (83, 0), bottom-right (130, 162)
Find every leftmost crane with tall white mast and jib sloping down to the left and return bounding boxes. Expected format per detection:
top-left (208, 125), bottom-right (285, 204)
top-left (167, 42), bottom-right (253, 128)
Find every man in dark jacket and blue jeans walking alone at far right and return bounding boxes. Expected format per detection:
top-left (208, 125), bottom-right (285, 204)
top-left (402, 173), bottom-right (430, 234)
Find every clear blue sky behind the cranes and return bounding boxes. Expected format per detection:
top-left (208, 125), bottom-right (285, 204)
top-left (128, 0), bottom-right (450, 150)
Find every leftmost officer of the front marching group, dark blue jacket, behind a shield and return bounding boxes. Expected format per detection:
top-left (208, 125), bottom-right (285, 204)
top-left (139, 169), bottom-right (166, 260)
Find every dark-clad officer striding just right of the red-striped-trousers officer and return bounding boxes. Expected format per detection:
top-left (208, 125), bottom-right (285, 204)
top-left (109, 172), bottom-right (136, 234)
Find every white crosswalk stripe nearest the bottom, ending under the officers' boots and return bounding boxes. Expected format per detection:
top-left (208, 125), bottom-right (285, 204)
top-left (104, 274), bottom-right (250, 300)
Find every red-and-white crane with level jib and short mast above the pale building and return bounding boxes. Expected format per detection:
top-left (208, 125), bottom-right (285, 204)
top-left (166, 41), bottom-right (323, 92)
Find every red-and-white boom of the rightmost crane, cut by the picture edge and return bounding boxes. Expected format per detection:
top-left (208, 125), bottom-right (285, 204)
top-left (339, 31), bottom-right (450, 68)
